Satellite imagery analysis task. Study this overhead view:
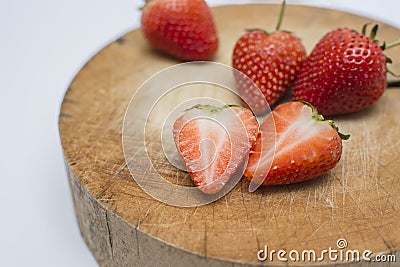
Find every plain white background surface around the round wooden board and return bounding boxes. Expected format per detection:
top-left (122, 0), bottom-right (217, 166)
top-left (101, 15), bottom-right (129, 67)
top-left (0, 0), bottom-right (400, 267)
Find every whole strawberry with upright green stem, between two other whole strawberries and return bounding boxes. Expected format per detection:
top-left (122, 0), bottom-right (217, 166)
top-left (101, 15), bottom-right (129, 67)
top-left (232, 1), bottom-right (306, 109)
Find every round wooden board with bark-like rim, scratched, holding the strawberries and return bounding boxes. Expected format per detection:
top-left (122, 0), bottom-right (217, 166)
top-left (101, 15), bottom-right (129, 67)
top-left (59, 5), bottom-right (400, 266)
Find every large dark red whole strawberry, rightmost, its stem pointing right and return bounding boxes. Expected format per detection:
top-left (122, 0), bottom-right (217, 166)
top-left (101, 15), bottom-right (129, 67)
top-left (293, 28), bottom-right (386, 115)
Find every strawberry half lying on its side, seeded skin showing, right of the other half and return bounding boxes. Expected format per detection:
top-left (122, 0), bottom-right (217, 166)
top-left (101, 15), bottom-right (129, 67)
top-left (245, 102), bottom-right (349, 191)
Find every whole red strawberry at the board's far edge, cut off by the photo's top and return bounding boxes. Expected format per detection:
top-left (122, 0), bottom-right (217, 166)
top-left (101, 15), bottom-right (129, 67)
top-left (141, 0), bottom-right (218, 60)
